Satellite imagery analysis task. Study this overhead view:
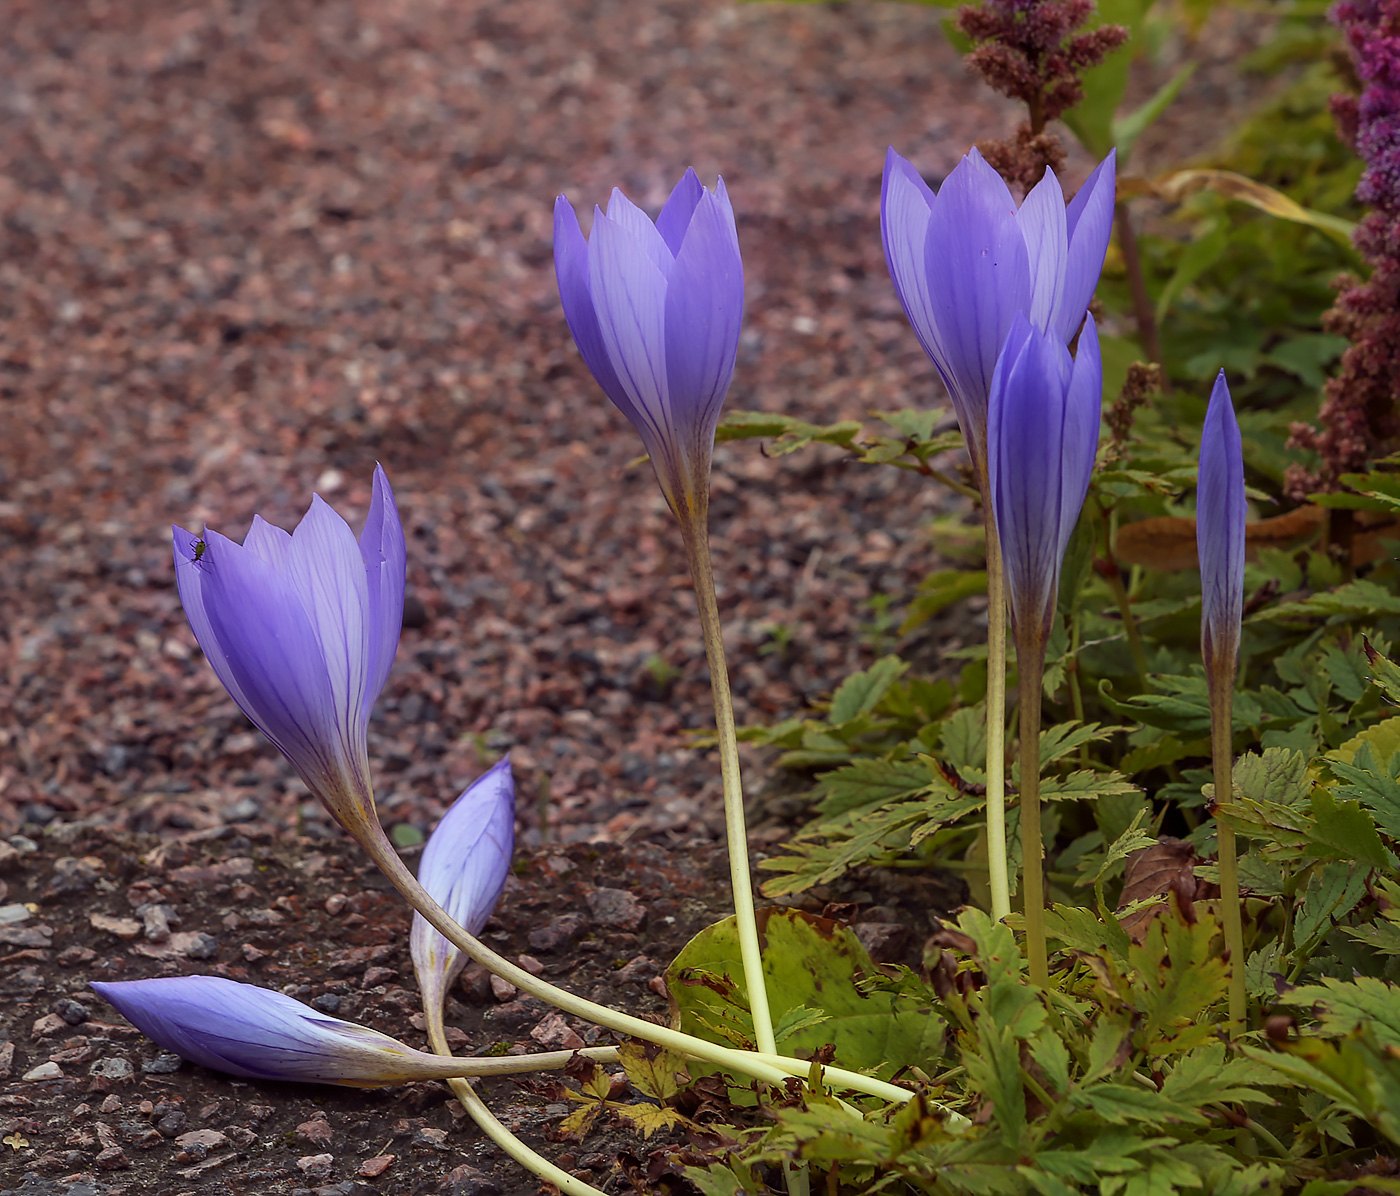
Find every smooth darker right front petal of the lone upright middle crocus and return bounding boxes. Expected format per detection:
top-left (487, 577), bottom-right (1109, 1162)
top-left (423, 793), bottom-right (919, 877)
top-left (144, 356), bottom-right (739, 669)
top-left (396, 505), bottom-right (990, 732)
top-left (665, 192), bottom-right (743, 478)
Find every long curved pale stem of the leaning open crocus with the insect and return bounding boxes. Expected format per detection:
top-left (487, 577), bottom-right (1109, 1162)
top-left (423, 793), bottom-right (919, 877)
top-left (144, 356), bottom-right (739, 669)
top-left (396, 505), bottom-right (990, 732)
top-left (355, 805), bottom-right (914, 1104)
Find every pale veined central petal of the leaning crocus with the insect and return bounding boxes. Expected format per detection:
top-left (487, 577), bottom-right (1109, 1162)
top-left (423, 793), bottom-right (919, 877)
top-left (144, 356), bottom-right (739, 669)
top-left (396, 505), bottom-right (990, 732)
top-left (287, 494), bottom-right (372, 741)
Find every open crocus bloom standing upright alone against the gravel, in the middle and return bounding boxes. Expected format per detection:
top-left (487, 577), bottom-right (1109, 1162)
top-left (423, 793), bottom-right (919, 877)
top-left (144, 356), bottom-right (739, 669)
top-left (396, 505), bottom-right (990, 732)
top-left (554, 169), bottom-right (743, 515)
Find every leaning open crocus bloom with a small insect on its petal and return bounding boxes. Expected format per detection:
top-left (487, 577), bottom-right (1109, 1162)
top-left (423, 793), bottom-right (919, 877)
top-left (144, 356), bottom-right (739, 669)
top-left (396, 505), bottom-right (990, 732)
top-left (172, 466), bottom-right (405, 837)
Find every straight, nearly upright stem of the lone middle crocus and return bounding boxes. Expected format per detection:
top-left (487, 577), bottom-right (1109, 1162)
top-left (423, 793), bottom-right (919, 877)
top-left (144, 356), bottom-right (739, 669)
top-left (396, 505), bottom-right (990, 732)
top-left (680, 513), bottom-right (777, 1055)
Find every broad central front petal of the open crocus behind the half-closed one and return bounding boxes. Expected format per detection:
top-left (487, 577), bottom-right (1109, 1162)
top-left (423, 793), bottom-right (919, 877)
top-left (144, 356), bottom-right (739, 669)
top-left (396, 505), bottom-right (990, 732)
top-left (924, 150), bottom-right (1030, 453)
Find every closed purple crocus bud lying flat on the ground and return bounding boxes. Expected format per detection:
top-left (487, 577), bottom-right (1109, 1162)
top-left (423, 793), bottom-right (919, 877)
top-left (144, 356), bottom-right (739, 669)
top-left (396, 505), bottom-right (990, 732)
top-left (92, 976), bottom-right (476, 1088)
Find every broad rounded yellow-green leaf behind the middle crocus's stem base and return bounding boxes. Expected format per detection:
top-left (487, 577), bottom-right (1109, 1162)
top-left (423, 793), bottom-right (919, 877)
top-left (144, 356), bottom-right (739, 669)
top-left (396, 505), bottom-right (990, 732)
top-left (666, 908), bottom-right (944, 1076)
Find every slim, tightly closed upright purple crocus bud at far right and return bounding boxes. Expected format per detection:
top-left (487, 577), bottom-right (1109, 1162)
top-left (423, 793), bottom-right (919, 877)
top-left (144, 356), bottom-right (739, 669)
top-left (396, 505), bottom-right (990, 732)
top-left (1196, 370), bottom-right (1246, 679)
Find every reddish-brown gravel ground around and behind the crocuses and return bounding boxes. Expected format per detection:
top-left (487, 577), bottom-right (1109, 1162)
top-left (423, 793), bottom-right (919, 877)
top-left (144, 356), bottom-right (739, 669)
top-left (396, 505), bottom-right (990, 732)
top-left (0, 0), bottom-right (1282, 1196)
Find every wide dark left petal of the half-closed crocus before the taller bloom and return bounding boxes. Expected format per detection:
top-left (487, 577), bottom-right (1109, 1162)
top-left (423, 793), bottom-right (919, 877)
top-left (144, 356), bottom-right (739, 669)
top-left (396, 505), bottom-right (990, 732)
top-left (987, 314), bottom-right (1064, 632)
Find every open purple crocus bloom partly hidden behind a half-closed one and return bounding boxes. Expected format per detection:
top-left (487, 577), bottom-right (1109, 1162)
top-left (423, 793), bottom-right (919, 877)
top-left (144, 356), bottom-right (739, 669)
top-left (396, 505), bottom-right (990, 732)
top-left (881, 147), bottom-right (1114, 471)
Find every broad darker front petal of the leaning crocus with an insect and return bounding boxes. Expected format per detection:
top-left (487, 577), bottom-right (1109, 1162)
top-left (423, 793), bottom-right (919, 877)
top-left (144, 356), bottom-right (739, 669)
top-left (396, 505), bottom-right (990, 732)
top-left (194, 531), bottom-right (352, 800)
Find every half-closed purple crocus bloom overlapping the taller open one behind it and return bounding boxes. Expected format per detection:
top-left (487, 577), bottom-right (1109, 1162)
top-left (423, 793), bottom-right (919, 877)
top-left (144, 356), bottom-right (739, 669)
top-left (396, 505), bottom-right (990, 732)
top-left (987, 315), bottom-right (1103, 644)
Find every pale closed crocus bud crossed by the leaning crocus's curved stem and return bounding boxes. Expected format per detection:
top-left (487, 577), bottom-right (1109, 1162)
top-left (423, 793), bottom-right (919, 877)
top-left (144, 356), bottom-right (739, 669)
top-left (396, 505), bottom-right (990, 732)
top-left (409, 756), bottom-right (515, 1008)
